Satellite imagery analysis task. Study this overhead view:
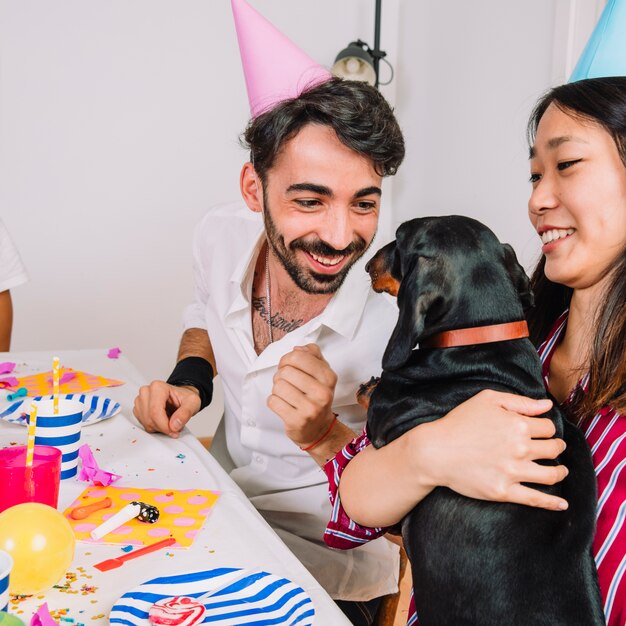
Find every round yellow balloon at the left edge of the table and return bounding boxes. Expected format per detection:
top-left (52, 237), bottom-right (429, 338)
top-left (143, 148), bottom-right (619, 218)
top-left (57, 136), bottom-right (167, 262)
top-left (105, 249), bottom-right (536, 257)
top-left (0, 502), bottom-right (76, 595)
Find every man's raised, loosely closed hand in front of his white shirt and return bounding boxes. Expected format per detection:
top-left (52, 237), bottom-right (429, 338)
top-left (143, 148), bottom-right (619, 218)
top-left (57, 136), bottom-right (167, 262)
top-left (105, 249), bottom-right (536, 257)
top-left (267, 343), bottom-right (337, 448)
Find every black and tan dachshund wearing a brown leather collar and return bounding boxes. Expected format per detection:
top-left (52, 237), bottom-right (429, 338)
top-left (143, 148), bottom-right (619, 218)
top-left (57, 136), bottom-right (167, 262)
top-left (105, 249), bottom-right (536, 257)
top-left (363, 216), bottom-right (605, 626)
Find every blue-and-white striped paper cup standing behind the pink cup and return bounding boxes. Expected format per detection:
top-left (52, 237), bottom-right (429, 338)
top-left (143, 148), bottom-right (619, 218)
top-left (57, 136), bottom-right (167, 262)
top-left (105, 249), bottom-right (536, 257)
top-left (35, 398), bottom-right (84, 480)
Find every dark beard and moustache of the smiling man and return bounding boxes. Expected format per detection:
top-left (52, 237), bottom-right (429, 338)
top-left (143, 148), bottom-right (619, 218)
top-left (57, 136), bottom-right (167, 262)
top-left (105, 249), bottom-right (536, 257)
top-left (263, 189), bottom-right (373, 294)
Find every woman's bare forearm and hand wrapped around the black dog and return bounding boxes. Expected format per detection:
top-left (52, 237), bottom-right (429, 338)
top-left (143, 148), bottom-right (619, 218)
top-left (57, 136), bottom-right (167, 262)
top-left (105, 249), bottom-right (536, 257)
top-left (339, 391), bottom-right (567, 527)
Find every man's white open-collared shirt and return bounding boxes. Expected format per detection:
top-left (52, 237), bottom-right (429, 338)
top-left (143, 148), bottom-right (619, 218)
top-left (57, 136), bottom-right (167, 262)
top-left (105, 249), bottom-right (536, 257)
top-left (184, 202), bottom-right (398, 600)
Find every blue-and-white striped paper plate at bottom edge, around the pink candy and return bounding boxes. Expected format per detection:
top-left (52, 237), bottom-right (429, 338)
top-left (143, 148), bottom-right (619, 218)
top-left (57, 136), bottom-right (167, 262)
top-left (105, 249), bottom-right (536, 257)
top-left (109, 568), bottom-right (315, 626)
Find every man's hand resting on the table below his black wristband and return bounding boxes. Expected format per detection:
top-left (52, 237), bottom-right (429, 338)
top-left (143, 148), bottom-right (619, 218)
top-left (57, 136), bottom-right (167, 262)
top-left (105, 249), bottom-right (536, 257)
top-left (133, 380), bottom-right (200, 438)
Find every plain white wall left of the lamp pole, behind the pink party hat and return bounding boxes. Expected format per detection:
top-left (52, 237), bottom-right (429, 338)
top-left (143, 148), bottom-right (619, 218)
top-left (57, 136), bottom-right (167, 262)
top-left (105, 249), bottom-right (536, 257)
top-left (0, 0), bottom-right (374, 377)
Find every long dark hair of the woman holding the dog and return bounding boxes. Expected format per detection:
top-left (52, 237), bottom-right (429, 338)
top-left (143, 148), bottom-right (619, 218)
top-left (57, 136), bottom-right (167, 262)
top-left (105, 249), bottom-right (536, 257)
top-left (528, 76), bottom-right (626, 423)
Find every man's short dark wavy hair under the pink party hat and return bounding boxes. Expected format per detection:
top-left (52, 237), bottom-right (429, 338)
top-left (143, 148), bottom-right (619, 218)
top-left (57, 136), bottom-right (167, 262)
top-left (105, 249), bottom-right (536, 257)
top-left (242, 78), bottom-right (404, 184)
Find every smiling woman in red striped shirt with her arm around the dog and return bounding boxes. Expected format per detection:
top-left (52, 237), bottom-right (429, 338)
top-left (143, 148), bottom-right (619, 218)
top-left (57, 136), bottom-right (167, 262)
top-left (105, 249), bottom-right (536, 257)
top-left (325, 77), bottom-right (626, 626)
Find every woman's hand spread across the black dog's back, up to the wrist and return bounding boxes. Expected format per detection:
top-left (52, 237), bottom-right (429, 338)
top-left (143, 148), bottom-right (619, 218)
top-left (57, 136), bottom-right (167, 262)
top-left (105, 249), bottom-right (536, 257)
top-left (413, 390), bottom-right (568, 510)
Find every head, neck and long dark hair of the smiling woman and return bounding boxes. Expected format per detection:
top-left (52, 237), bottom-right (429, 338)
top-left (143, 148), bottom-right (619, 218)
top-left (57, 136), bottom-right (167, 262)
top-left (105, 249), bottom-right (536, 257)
top-left (528, 77), bottom-right (626, 421)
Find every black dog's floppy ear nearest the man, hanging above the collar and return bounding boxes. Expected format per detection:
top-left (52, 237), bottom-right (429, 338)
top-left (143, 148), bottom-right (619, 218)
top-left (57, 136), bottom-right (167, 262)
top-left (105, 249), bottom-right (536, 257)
top-left (383, 262), bottom-right (441, 370)
